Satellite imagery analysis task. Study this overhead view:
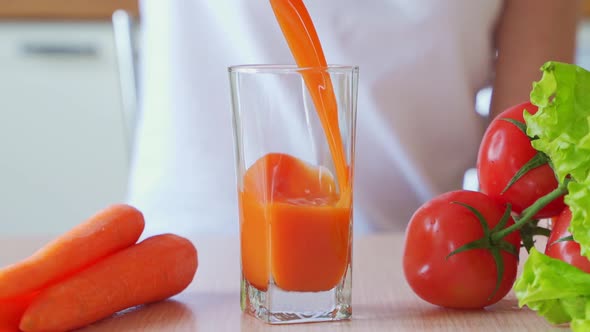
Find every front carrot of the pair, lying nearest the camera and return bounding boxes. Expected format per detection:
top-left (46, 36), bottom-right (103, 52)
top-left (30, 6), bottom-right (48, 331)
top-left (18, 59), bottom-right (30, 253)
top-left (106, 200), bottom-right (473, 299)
top-left (20, 234), bottom-right (198, 332)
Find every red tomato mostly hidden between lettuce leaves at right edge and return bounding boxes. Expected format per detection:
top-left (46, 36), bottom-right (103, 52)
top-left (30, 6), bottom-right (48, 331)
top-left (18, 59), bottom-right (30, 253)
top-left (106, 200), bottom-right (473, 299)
top-left (545, 208), bottom-right (590, 273)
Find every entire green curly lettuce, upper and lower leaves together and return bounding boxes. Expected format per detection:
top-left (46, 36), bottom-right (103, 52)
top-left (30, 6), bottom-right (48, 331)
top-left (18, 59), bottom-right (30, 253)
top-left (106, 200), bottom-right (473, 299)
top-left (514, 62), bottom-right (590, 331)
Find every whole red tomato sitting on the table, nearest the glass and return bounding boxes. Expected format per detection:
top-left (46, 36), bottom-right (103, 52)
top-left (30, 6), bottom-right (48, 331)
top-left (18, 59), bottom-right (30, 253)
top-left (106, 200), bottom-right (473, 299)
top-left (403, 190), bottom-right (520, 308)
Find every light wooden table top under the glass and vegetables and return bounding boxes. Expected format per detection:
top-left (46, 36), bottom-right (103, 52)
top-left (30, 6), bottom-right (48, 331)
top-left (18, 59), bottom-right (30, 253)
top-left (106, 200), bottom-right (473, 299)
top-left (0, 234), bottom-right (567, 332)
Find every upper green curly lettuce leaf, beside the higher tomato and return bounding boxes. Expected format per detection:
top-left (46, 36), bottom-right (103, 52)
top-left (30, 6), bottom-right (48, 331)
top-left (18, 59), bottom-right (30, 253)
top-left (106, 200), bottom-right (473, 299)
top-left (524, 62), bottom-right (590, 258)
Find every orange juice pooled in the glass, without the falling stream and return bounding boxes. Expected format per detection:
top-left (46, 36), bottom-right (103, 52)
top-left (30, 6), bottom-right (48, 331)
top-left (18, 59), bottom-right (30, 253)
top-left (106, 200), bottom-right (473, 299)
top-left (240, 153), bottom-right (351, 291)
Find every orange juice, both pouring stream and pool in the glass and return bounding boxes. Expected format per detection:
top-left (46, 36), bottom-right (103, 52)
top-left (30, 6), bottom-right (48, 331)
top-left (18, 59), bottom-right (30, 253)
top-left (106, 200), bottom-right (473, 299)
top-left (239, 0), bottom-right (351, 292)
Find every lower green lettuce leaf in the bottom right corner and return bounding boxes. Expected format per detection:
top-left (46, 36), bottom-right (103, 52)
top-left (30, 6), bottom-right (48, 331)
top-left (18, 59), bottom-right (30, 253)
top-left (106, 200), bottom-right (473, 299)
top-left (514, 248), bottom-right (590, 331)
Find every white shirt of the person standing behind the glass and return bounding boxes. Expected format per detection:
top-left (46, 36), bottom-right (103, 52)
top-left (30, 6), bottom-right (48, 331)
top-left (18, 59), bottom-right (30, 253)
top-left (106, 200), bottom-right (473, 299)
top-left (130, 0), bottom-right (501, 233)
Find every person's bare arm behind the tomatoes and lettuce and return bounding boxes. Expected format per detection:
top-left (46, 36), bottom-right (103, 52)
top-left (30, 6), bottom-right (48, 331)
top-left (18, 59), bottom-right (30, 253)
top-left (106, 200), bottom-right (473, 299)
top-left (490, 0), bottom-right (580, 117)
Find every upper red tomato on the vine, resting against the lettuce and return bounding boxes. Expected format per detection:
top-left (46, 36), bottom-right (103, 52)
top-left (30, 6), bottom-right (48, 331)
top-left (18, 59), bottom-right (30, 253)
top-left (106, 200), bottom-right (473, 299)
top-left (477, 103), bottom-right (565, 218)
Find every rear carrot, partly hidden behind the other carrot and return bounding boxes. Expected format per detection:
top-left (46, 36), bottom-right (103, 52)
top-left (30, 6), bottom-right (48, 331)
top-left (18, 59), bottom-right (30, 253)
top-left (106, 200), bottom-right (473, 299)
top-left (0, 204), bottom-right (144, 299)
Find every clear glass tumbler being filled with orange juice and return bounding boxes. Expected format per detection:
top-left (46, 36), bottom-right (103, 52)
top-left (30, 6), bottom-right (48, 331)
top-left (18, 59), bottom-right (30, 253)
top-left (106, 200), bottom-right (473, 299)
top-left (229, 65), bottom-right (358, 324)
